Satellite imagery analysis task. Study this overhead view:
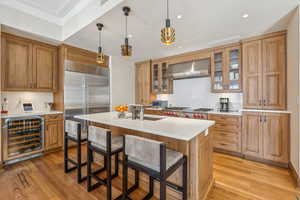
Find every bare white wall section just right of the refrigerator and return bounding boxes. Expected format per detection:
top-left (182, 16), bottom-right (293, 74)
top-left (110, 56), bottom-right (135, 106)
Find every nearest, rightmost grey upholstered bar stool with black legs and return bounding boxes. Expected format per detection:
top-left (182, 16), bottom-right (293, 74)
top-left (117, 135), bottom-right (187, 200)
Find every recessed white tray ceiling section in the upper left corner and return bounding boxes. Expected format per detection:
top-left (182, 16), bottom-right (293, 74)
top-left (0, 0), bottom-right (124, 41)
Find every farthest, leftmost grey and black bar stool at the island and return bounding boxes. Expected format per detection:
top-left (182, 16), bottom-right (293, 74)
top-left (64, 120), bottom-right (87, 183)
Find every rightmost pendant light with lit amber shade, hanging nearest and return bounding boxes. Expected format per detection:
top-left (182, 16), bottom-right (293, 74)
top-left (160, 0), bottom-right (175, 45)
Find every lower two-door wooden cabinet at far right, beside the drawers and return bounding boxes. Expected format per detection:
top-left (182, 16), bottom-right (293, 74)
top-left (242, 112), bottom-right (289, 164)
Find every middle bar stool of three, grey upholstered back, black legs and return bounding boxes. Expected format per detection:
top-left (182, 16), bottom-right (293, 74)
top-left (87, 126), bottom-right (137, 200)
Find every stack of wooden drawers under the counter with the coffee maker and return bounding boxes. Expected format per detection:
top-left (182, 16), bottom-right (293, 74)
top-left (208, 114), bottom-right (242, 153)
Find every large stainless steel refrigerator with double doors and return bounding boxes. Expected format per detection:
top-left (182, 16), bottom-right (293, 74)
top-left (64, 61), bottom-right (110, 132)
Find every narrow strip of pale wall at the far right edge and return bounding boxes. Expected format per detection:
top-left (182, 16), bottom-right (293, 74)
top-left (287, 8), bottom-right (300, 174)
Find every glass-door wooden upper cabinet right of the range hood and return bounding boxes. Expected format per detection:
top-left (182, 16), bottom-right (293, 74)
top-left (211, 45), bottom-right (242, 93)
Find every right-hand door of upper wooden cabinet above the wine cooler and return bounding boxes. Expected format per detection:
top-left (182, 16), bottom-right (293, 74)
top-left (33, 44), bottom-right (57, 90)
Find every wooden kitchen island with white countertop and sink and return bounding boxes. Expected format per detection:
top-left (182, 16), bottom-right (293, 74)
top-left (75, 112), bottom-right (215, 200)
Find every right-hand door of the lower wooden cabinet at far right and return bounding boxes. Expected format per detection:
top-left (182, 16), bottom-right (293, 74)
top-left (263, 113), bottom-right (289, 163)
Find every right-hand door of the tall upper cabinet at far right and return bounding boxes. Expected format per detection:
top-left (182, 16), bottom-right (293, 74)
top-left (263, 36), bottom-right (286, 110)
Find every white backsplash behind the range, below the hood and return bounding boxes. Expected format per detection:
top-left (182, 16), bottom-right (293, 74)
top-left (158, 77), bottom-right (242, 110)
